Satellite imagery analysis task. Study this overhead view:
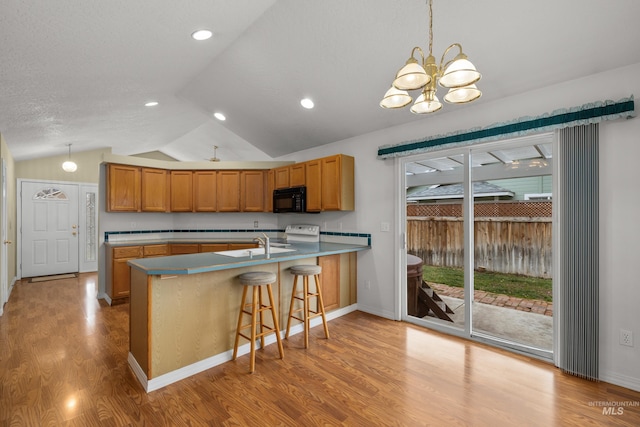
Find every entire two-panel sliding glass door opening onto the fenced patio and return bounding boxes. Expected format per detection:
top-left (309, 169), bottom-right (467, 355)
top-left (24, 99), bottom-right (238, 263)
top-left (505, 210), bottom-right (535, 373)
top-left (403, 134), bottom-right (553, 358)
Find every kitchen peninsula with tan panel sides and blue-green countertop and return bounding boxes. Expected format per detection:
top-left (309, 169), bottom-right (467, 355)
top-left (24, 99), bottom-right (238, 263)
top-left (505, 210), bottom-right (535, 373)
top-left (128, 237), bottom-right (371, 392)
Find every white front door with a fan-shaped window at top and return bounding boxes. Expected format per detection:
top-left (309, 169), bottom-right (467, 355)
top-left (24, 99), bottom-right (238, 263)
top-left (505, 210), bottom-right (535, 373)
top-left (21, 181), bottom-right (79, 277)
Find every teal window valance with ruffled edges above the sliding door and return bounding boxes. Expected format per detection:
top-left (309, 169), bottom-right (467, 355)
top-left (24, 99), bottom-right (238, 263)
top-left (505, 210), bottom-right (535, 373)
top-left (378, 95), bottom-right (636, 159)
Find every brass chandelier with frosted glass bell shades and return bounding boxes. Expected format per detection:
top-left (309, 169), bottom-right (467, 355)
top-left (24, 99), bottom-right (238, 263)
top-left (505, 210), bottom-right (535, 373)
top-left (380, 0), bottom-right (482, 114)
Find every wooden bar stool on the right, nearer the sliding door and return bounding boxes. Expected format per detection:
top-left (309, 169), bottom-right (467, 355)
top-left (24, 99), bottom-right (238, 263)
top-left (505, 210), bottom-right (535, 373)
top-left (285, 265), bottom-right (329, 348)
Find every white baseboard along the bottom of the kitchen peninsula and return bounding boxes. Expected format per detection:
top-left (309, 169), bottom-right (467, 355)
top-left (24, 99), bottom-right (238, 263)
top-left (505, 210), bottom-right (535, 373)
top-left (127, 304), bottom-right (358, 393)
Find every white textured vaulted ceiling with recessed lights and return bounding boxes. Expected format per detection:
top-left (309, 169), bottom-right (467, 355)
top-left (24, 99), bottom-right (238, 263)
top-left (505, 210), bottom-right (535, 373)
top-left (0, 0), bottom-right (640, 161)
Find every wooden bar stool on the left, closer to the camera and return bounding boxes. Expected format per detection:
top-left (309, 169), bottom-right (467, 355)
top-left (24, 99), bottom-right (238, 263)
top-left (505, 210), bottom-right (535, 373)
top-left (232, 271), bottom-right (284, 373)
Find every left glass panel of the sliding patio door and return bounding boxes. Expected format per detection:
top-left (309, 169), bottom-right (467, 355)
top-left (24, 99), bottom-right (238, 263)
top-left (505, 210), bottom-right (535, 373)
top-left (406, 154), bottom-right (465, 329)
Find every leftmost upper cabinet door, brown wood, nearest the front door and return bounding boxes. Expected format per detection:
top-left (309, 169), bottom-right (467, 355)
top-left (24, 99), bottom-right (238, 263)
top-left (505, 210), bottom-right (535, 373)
top-left (107, 164), bottom-right (140, 212)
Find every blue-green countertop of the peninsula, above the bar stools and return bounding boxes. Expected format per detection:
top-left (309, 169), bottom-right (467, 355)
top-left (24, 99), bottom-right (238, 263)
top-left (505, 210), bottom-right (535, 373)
top-left (128, 242), bottom-right (371, 275)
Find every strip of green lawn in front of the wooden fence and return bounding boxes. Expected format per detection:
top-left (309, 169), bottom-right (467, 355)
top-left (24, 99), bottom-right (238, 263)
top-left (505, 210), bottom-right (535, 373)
top-left (422, 265), bottom-right (552, 301)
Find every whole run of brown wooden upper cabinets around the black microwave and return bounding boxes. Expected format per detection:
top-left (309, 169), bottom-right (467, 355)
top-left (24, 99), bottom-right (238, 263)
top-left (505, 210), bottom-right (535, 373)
top-left (107, 154), bottom-right (355, 212)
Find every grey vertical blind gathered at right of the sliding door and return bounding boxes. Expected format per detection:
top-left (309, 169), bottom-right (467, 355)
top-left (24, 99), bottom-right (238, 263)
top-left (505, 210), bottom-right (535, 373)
top-left (556, 123), bottom-right (599, 380)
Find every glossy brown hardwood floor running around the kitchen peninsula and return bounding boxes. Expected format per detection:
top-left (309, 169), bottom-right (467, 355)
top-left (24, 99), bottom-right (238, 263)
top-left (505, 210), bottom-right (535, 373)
top-left (0, 274), bottom-right (640, 427)
